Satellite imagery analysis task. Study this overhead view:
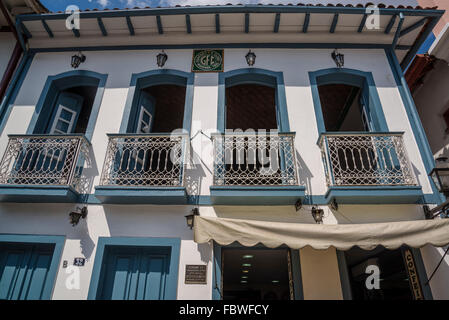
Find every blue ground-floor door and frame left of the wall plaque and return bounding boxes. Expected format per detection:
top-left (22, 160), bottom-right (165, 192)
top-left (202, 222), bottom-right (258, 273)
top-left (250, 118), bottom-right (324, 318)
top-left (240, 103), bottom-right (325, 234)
top-left (88, 237), bottom-right (181, 300)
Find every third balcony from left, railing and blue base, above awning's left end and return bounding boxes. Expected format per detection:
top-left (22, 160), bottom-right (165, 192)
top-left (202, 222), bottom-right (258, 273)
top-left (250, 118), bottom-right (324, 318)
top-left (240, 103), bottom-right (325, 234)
top-left (210, 133), bottom-right (305, 205)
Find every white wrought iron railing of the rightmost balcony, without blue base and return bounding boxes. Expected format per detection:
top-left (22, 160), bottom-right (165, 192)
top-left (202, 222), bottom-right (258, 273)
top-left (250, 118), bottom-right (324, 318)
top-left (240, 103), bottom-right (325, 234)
top-left (320, 132), bottom-right (416, 186)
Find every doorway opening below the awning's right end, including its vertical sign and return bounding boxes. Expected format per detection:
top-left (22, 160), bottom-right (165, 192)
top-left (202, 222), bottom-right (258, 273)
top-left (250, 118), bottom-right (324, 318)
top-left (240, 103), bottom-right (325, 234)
top-left (345, 246), bottom-right (423, 300)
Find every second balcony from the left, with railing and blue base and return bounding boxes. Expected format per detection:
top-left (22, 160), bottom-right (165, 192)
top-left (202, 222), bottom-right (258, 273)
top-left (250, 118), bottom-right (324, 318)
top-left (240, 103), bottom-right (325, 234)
top-left (95, 134), bottom-right (188, 204)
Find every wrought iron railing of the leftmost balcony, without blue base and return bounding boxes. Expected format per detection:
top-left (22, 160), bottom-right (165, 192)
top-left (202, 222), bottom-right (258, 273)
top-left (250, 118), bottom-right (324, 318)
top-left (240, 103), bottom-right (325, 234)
top-left (0, 135), bottom-right (89, 191)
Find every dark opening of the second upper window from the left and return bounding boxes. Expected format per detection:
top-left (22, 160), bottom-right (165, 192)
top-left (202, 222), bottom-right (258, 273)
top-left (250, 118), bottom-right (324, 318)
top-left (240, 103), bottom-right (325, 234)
top-left (143, 85), bottom-right (186, 133)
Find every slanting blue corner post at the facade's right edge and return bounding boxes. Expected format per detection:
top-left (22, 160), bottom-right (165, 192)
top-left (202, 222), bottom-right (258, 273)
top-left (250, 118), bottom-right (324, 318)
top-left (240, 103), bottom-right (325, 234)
top-left (385, 48), bottom-right (445, 204)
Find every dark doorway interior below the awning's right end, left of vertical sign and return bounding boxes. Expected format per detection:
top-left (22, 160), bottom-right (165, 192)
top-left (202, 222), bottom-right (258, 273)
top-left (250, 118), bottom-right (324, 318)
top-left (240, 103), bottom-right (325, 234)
top-left (345, 246), bottom-right (413, 300)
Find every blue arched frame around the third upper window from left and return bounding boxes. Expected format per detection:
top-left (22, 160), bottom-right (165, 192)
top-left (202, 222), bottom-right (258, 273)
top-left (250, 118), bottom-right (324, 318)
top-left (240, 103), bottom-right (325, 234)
top-left (217, 68), bottom-right (290, 132)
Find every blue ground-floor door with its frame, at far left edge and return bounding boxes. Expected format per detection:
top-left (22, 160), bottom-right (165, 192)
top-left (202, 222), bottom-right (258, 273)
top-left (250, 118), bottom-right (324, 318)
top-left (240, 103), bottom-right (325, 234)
top-left (0, 234), bottom-right (65, 300)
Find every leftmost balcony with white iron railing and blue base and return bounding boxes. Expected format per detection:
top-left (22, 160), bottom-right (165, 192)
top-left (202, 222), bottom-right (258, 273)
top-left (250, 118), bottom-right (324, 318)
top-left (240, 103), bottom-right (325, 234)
top-left (0, 135), bottom-right (89, 202)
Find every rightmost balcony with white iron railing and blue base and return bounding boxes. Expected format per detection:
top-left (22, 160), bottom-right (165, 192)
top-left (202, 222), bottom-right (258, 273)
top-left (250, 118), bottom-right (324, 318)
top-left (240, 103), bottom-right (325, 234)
top-left (319, 132), bottom-right (422, 204)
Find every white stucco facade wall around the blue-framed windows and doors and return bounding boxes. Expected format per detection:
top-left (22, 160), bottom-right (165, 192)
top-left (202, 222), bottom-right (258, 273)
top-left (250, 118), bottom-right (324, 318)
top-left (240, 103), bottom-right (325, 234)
top-left (0, 49), bottom-right (438, 299)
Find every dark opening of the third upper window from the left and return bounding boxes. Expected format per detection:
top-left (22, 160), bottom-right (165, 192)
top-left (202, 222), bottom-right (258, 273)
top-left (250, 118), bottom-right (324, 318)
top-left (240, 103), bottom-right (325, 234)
top-left (226, 84), bottom-right (277, 131)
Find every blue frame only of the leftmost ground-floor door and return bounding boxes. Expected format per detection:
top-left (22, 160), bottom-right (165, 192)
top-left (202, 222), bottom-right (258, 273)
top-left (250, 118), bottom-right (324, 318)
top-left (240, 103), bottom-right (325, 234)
top-left (0, 234), bottom-right (65, 300)
